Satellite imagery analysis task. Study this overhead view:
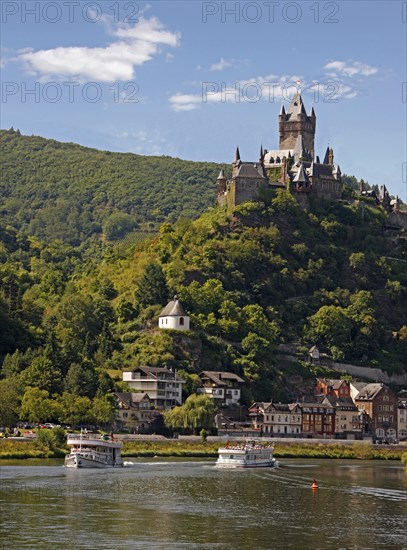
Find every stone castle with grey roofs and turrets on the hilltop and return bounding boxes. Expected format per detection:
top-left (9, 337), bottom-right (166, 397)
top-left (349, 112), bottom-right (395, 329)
top-left (217, 93), bottom-right (342, 207)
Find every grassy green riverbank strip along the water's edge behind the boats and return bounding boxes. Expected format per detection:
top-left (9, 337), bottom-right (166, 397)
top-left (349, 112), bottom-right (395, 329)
top-left (0, 439), bottom-right (406, 460)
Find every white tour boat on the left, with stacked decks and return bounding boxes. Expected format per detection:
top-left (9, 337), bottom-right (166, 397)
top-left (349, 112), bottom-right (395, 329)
top-left (65, 433), bottom-right (123, 468)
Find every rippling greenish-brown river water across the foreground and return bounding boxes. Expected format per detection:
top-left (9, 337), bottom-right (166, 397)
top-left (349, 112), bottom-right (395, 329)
top-left (0, 459), bottom-right (407, 550)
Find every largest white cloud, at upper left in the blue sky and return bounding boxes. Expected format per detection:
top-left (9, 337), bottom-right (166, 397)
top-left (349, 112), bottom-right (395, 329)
top-left (19, 17), bottom-right (180, 82)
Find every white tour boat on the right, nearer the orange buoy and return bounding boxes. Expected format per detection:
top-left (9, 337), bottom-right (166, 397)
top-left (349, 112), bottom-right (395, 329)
top-left (216, 443), bottom-right (279, 468)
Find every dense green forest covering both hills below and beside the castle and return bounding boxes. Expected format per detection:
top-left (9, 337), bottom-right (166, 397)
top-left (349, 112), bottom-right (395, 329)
top-left (0, 131), bottom-right (407, 423)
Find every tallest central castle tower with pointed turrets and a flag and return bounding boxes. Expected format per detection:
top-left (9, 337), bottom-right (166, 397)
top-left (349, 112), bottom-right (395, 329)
top-left (278, 93), bottom-right (317, 159)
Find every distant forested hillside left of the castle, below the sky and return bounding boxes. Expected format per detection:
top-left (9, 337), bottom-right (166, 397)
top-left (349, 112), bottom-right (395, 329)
top-left (0, 130), bottom-right (219, 245)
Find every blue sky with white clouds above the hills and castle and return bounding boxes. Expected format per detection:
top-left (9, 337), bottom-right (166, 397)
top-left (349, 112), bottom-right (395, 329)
top-left (1, 0), bottom-right (407, 201)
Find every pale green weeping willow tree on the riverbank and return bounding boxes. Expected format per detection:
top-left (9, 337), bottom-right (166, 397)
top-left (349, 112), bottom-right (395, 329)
top-left (165, 394), bottom-right (216, 434)
